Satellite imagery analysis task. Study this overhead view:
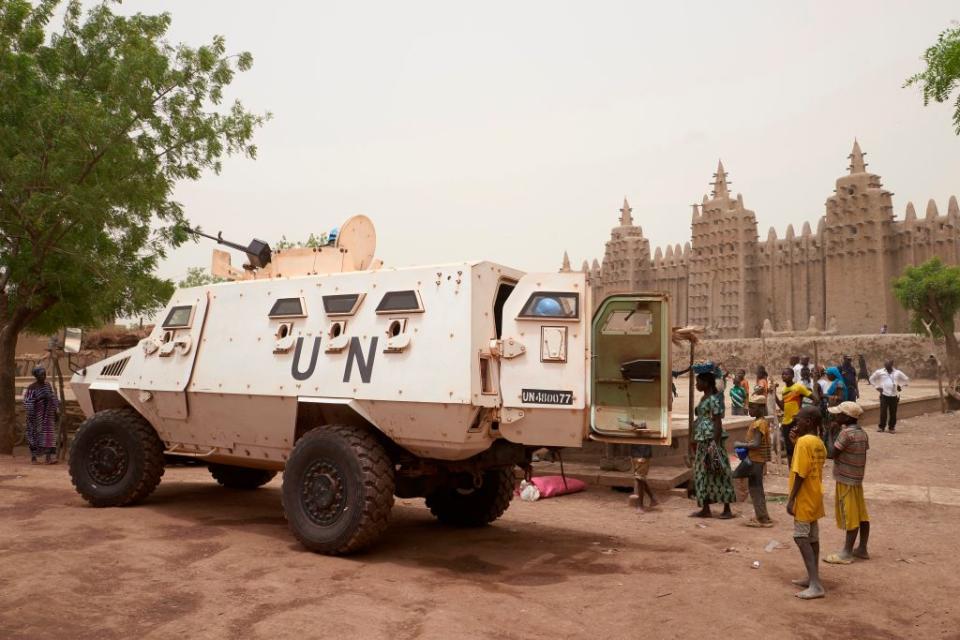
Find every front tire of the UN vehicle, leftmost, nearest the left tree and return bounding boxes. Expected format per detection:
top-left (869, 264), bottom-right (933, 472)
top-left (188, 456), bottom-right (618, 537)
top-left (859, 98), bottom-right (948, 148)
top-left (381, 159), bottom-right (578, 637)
top-left (70, 409), bottom-right (164, 507)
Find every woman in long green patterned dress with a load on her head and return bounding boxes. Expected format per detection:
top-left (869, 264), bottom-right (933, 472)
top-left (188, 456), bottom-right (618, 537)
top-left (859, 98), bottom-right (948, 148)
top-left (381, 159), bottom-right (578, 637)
top-left (690, 371), bottom-right (737, 519)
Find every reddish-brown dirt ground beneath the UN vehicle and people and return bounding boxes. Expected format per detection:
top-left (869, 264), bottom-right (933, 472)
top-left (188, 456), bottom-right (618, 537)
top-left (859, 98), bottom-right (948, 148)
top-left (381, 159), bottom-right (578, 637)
top-left (0, 414), bottom-right (960, 640)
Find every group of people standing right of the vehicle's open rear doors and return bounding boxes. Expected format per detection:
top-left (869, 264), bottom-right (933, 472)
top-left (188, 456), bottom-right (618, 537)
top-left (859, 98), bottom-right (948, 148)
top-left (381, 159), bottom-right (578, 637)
top-left (690, 356), bottom-right (909, 599)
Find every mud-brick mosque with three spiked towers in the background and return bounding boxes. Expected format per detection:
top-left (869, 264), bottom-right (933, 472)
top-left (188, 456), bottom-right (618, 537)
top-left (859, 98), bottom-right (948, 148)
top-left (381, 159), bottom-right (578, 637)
top-left (561, 142), bottom-right (960, 338)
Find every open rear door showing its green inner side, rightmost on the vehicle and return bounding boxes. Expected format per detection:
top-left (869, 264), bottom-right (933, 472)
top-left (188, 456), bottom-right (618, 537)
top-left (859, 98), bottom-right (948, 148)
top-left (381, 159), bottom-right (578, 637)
top-left (590, 294), bottom-right (672, 445)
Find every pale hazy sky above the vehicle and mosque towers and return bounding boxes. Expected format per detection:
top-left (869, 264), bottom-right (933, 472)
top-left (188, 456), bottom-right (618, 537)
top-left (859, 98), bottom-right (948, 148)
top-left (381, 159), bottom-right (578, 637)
top-left (114, 0), bottom-right (960, 278)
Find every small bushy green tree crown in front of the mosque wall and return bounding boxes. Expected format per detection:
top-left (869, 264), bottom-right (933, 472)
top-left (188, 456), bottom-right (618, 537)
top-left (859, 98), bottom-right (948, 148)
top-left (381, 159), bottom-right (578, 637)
top-left (893, 258), bottom-right (960, 338)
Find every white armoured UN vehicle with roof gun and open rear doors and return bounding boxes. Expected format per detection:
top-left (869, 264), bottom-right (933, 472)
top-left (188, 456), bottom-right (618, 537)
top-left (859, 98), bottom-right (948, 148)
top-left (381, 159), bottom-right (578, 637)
top-left (70, 216), bottom-right (671, 554)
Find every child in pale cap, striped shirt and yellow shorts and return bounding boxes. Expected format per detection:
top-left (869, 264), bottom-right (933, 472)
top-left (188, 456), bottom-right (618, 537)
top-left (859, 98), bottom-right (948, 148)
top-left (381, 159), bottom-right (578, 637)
top-left (824, 401), bottom-right (870, 564)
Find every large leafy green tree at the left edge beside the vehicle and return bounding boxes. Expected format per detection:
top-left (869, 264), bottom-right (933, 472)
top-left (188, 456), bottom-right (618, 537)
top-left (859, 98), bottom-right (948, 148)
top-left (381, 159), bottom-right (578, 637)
top-left (0, 0), bottom-right (269, 453)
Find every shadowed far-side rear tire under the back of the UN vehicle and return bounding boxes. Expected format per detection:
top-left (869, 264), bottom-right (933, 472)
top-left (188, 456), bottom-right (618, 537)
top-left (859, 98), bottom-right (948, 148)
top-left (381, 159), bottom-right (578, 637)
top-left (427, 467), bottom-right (516, 527)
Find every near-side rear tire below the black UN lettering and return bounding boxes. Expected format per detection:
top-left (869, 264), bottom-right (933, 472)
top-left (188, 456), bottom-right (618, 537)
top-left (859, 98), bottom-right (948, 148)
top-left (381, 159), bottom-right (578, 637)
top-left (281, 425), bottom-right (395, 555)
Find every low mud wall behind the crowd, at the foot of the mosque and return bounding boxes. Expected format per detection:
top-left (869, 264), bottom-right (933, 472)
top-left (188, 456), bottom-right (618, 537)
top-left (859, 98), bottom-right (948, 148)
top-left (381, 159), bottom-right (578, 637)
top-left (673, 333), bottom-right (944, 379)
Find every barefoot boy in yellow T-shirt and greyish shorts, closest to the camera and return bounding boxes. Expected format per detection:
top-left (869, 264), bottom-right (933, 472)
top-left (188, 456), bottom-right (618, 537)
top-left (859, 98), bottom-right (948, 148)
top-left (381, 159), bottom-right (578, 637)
top-left (787, 407), bottom-right (827, 600)
